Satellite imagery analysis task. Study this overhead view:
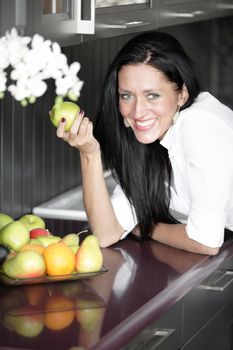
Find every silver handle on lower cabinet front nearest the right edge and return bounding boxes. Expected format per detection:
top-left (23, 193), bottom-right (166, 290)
top-left (198, 270), bottom-right (233, 292)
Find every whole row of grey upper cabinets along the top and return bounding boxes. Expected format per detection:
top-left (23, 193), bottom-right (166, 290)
top-left (0, 0), bottom-right (233, 46)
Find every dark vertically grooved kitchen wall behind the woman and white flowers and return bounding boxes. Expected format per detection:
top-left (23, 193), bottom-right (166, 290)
top-left (0, 17), bottom-right (233, 218)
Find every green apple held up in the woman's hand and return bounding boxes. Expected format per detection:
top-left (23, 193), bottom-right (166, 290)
top-left (50, 101), bottom-right (80, 131)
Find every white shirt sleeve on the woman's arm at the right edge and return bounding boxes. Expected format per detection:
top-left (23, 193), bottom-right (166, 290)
top-left (183, 110), bottom-right (233, 248)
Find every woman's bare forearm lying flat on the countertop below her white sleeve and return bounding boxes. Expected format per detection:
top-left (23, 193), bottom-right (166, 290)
top-left (152, 223), bottom-right (219, 255)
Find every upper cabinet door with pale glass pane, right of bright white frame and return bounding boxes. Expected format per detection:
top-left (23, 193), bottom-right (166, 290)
top-left (84, 0), bottom-right (158, 41)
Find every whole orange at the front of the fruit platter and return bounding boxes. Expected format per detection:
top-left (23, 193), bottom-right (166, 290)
top-left (43, 242), bottom-right (75, 276)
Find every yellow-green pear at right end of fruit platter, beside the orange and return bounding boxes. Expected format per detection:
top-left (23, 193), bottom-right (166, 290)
top-left (75, 235), bottom-right (103, 273)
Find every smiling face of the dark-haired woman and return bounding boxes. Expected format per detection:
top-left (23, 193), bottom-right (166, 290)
top-left (118, 63), bottom-right (187, 144)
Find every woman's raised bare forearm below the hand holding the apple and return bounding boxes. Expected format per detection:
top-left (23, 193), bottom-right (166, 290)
top-left (80, 150), bottom-right (124, 247)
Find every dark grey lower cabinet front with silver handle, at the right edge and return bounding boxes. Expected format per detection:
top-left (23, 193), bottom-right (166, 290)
top-left (181, 252), bottom-right (233, 350)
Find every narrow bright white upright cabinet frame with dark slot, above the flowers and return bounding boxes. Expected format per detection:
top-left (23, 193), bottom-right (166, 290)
top-left (76, 0), bottom-right (95, 34)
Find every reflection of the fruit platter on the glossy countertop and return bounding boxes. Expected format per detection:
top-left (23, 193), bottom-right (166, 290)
top-left (0, 281), bottom-right (105, 338)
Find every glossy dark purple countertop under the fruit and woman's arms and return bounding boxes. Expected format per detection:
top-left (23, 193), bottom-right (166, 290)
top-left (0, 219), bottom-right (233, 350)
